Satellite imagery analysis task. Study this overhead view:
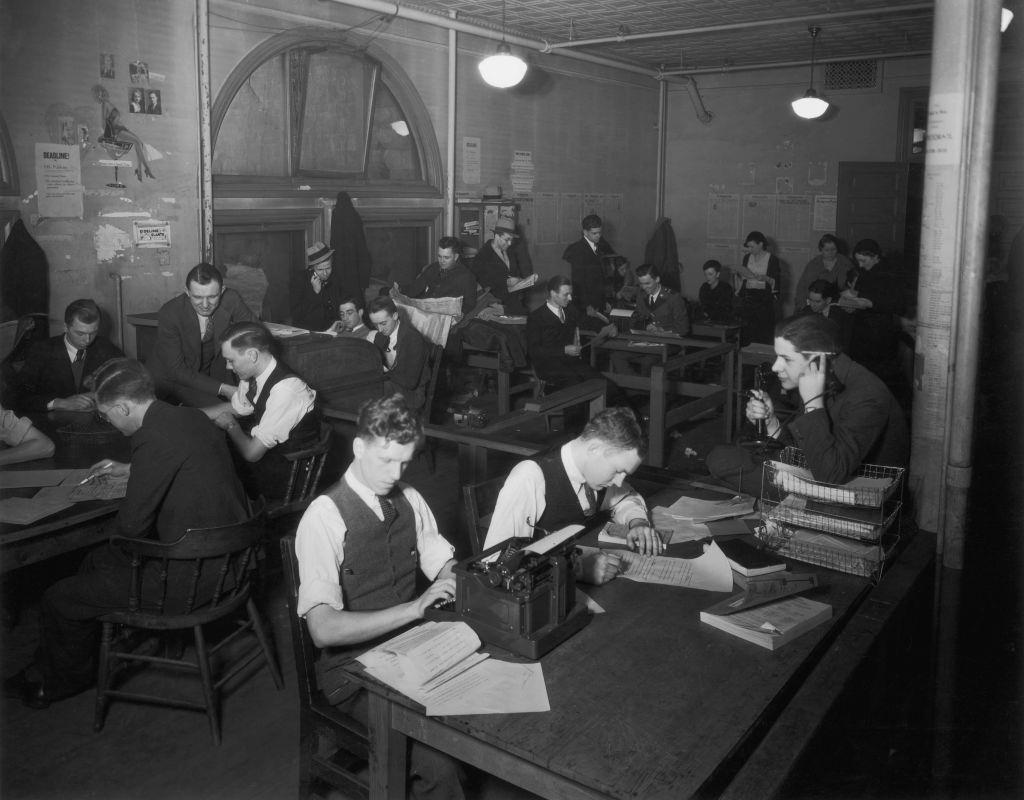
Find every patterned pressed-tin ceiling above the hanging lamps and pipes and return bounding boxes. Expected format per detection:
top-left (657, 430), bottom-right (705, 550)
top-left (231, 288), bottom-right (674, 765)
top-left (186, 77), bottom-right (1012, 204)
top-left (400, 0), bottom-right (933, 72)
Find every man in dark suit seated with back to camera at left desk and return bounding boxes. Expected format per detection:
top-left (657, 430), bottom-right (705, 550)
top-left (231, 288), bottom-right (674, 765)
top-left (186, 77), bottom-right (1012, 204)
top-left (4, 359), bottom-right (248, 709)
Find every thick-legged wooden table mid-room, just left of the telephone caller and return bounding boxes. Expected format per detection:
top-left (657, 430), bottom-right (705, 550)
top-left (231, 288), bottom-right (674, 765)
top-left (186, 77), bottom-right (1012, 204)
top-left (591, 333), bottom-right (736, 467)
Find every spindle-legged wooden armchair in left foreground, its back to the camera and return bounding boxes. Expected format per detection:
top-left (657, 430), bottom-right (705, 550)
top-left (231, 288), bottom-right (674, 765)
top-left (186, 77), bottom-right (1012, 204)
top-left (93, 515), bottom-right (284, 745)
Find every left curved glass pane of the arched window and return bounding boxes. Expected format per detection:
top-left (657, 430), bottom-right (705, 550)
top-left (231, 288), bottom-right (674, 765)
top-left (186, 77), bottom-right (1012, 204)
top-left (213, 57), bottom-right (288, 175)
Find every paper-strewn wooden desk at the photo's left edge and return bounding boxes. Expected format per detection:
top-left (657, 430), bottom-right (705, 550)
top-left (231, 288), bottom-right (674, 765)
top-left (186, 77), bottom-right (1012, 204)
top-left (0, 411), bottom-right (131, 573)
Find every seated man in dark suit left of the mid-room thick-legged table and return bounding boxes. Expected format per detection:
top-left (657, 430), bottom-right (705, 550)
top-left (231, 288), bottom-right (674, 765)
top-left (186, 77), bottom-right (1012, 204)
top-left (526, 275), bottom-right (615, 389)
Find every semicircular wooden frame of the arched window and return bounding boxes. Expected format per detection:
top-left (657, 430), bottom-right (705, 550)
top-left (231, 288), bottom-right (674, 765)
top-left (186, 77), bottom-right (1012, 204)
top-left (211, 27), bottom-right (444, 199)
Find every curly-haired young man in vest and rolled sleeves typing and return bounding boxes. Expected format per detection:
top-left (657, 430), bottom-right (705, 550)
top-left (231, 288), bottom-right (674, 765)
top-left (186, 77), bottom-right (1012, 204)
top-left (295, 394), bottom-right (464, 800)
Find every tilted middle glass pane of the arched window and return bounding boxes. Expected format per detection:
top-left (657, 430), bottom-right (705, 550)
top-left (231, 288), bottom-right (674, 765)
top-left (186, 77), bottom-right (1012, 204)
top-left (299, 51), bottom-right (374, 174)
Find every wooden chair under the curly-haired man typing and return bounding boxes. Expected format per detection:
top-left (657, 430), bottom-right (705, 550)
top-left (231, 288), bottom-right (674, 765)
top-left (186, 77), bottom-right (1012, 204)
top-left (281, 536), bottom-right (370, 799)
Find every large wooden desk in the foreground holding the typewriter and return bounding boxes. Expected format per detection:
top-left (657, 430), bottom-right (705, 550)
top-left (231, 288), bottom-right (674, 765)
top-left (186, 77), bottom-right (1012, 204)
top-left (353, 514), bottom-right (934, 800)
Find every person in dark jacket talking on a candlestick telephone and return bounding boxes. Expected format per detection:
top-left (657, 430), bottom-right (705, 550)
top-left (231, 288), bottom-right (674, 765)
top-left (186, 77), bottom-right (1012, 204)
top-left (707, 314), bottom-right (908, 492)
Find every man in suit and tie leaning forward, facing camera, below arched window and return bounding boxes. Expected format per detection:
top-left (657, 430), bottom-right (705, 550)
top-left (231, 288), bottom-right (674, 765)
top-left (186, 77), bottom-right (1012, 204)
top-left (150, 262), bottom-right (256, 408)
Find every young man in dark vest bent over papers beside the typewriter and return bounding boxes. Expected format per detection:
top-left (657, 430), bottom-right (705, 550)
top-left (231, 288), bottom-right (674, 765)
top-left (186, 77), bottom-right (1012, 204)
top-left (483, 408), bottom-right (664, 584)
